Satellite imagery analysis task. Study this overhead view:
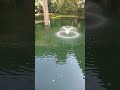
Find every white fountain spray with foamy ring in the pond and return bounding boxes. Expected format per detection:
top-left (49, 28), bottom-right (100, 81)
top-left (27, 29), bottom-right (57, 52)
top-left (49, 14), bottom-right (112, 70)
top-left (56, 26), bottom-right (80, 39)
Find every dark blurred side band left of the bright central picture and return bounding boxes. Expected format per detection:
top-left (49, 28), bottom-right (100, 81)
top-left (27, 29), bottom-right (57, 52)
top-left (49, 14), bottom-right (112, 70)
top-left (0, 0), bottom-right (34, 90)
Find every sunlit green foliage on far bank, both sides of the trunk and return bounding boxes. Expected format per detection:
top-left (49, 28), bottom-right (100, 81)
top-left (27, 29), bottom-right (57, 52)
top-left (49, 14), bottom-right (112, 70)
top-left (35, 0), bottom-right (85, 17)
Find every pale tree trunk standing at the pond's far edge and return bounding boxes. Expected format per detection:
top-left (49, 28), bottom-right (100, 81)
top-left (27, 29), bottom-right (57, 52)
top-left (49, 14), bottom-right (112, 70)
top-left (43, 0), bottom-right (50, 25)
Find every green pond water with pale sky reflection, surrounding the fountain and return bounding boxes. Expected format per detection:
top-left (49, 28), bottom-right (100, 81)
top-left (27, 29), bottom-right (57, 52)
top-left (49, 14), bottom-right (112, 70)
top-left (35, 19), bottom-right (85, 90)
